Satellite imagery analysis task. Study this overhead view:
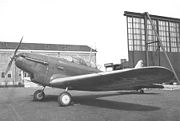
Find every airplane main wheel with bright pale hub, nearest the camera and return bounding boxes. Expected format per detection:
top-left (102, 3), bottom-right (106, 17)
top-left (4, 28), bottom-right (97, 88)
top-left (58, 92), bottom-right (72, 106)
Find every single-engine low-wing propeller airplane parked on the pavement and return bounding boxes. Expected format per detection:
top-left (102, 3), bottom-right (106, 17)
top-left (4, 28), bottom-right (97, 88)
top-left (5, 37), bottom-right (174, 106)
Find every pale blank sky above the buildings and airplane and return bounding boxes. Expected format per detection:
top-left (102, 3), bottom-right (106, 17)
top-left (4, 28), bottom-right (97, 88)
top-left (0, 0), bottom-right (180, 69)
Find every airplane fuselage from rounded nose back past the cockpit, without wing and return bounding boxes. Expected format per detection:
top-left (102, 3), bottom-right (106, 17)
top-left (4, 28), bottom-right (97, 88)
top-left (15, 53), bottom-right (101, 86)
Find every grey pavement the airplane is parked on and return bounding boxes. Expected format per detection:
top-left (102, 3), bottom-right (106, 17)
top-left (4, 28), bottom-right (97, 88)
top-left (0, 88), bottom-right (180, 121)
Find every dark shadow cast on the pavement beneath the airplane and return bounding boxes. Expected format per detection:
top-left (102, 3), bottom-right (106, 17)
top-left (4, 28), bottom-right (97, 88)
top-left (39, 92), bottom-right (160, 111)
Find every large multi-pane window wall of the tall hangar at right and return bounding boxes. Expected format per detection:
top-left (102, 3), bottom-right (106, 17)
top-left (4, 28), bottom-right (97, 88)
top-left (125, 12), bottom-right (180, 52)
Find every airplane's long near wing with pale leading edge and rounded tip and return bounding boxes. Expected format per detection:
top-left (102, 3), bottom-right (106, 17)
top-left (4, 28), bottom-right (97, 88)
top-left (50, 66), bottom-right (174, 91)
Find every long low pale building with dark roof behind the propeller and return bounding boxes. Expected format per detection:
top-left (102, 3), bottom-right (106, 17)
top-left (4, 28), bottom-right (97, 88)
top-left (0, 42), bottom-right (97, 87)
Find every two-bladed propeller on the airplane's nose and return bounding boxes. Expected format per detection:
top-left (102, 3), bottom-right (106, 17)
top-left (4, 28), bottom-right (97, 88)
top-left (5, 36), bottom-right (23, 75)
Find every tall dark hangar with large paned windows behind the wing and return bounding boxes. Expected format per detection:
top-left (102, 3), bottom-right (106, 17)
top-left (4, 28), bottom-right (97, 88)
top-left (124, 11), bottom-right (180, 79)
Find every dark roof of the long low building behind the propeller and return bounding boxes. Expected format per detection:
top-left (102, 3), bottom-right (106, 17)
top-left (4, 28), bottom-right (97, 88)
top-left (0, 42), bottom-right (96, 52)
